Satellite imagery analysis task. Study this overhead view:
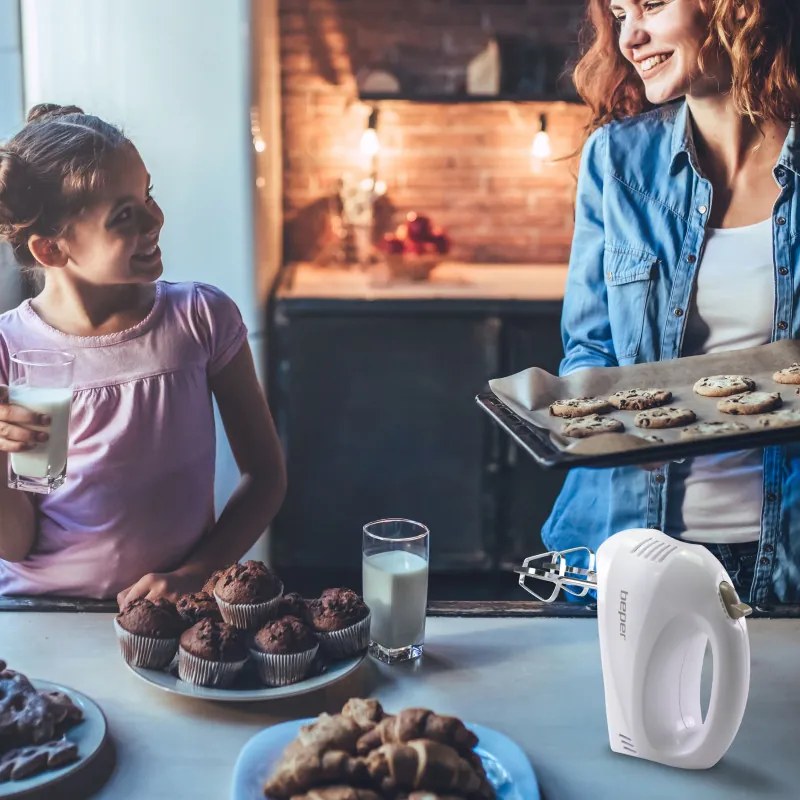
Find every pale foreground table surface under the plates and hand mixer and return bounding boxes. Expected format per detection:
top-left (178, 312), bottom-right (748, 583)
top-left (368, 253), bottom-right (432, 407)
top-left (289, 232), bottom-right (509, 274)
top-left (0, 611), bottom-right (800, 800)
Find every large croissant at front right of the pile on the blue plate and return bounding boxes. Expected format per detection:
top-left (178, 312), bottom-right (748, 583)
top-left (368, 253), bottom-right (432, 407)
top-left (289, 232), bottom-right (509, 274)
top-left (365, 739), bottom-right (494, 800)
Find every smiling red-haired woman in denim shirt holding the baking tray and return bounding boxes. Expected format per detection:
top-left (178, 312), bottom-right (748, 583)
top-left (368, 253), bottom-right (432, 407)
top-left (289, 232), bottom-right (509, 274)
top-left (543, 0), bottom-right (800, 605)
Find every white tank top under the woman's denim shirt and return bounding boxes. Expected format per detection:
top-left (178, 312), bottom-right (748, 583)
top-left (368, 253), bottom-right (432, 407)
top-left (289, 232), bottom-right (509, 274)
top-left (666, 218), bottom-right (775, 544)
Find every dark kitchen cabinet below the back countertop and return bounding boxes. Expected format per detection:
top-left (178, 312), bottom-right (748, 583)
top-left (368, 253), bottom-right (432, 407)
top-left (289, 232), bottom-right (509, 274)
top-left (269, 266), bottom-right (563, 599)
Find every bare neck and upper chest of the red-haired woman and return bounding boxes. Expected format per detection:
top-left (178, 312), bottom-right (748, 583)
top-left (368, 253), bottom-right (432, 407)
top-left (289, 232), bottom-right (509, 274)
top-left (686, 94), bottom-right (789, 185)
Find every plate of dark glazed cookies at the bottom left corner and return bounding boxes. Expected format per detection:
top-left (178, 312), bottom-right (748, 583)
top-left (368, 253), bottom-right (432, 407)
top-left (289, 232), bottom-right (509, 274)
top-left (0, 661), bottom-right (106, 798)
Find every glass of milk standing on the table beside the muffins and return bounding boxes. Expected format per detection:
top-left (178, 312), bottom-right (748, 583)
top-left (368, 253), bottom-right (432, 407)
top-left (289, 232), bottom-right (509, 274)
top-left (362, 519), bottom-right (430, 664)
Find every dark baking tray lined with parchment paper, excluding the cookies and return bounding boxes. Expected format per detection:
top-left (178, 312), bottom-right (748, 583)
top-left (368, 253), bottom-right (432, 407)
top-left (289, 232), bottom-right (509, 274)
top-left (477, 339), bottom-right (800, 468)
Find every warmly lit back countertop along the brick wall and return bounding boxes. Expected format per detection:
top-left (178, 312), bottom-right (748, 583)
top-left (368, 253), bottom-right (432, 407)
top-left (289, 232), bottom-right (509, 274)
top-left (276, 261), bottom-right (567, 300)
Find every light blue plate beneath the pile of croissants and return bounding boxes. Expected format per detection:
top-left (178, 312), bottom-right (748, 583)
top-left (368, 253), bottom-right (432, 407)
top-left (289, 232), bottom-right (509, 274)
top-left (231, 717), bottom-right (540, 800)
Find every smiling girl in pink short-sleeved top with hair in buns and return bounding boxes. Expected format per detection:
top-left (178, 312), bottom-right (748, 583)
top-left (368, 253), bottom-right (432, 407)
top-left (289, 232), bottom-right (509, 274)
top-left (0, 105), bottom-right (286, 606)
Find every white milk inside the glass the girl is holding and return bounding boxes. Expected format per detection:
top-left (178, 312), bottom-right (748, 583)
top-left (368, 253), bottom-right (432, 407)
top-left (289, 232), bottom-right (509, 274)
top-left (9, 385), bottom-right (72, 478)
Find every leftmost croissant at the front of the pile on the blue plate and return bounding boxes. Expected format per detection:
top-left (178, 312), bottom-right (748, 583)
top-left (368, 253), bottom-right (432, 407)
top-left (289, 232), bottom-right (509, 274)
top-left (264, 748), bottom-right (368, 800)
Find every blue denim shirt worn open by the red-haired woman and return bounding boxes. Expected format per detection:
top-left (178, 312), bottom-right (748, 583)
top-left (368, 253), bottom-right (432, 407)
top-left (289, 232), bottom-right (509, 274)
top-left (542, 101), bottom-right (800, 605)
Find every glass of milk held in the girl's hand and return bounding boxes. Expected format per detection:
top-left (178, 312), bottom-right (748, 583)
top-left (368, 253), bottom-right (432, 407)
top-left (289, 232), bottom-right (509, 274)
top-left (8, 350), bottom-right (75, 494)
